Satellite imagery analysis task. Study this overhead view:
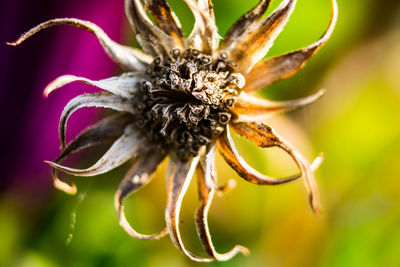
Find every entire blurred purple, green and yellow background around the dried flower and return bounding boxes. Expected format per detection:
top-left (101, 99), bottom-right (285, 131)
top-left (0, 0), bottom-right (400, 267)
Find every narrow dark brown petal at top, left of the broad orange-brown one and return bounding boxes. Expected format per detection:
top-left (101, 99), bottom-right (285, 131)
top-left (220, 0), bottom-right (271, 50)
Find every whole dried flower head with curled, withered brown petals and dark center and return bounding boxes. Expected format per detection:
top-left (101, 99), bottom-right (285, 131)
top-left (10, 0), bottom-right (337, 261)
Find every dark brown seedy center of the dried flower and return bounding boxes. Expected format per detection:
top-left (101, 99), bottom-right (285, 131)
top-left (135, 49), bottom-right (245, 158)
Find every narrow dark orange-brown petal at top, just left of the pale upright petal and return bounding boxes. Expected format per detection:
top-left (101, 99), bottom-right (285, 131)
top-left (146, 0), bottom-right (183, 47)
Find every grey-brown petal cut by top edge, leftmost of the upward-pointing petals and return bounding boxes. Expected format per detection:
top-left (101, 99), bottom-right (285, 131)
top-left (125, 0), bottom-right (180, 58)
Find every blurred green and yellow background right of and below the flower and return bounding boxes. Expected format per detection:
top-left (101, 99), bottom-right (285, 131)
top-left (0, 0), bottom-right (400, 267)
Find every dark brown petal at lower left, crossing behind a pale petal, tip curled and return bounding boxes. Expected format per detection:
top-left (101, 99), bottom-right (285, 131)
top-left (52, 114), bottom-right (132, 194)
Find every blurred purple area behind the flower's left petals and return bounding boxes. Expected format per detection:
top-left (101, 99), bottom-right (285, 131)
top-left (0, 0), bottom-right (126, 200)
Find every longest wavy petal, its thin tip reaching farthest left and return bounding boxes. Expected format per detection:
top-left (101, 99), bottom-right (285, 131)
top-left (7, 18), bottom-right (152, 71)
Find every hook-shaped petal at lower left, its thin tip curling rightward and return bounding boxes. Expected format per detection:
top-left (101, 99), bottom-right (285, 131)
top-left (115, 150), bottom-right (168, 239)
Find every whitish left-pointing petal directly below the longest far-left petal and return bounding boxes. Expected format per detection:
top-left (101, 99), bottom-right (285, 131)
top-left (43, 72), bottom-right (146, 98)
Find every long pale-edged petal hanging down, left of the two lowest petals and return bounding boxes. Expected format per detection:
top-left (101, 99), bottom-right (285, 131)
top-left (165, 155), bottom-right (213, 262)
